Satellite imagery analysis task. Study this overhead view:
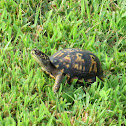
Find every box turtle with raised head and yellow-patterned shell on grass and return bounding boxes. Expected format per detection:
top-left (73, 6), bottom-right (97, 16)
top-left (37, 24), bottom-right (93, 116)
top-left (31, 48), bottom-right (104, 93)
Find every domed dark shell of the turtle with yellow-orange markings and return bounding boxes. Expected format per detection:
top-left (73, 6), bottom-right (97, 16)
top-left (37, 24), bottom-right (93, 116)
top-left (50, 48), bottom-right (103, 82)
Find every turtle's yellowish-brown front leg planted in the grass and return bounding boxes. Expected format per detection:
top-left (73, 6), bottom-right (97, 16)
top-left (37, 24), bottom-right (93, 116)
top-left (53, 74), bottom-right (64, 93)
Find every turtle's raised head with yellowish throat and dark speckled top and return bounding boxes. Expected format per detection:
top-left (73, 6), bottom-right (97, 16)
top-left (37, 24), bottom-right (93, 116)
top-left (31, 49), bottom-right (50, 71)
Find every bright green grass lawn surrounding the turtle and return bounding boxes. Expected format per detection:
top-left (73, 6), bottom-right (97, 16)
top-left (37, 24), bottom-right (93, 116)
top-left (0, 0), bottom-right (126, 126)
